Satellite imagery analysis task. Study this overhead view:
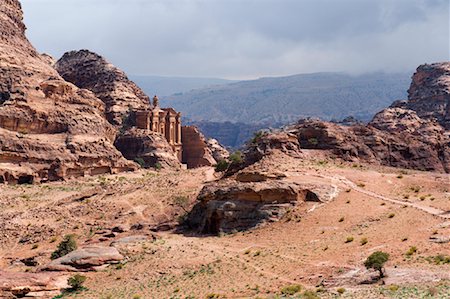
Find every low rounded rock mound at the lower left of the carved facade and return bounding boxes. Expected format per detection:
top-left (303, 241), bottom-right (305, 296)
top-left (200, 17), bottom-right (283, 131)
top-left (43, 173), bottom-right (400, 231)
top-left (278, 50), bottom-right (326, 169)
top-left (115, 127), bottom-right (181, 168)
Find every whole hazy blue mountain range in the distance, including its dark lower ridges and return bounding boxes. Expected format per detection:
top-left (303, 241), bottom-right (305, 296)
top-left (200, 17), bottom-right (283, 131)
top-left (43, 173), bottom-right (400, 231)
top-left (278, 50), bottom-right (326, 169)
top-left (132, 72), bottom-right (412, 148)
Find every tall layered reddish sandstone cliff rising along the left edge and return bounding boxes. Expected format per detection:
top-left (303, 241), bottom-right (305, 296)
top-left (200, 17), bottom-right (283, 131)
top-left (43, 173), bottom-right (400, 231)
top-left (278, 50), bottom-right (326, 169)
top-left (0, 0), bottom-right (136, 183)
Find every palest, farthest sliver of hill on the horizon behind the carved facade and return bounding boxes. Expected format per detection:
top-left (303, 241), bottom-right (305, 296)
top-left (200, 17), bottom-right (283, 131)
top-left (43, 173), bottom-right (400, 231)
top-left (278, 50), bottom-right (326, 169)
top-left (130, 76), bottom-right (236, 96)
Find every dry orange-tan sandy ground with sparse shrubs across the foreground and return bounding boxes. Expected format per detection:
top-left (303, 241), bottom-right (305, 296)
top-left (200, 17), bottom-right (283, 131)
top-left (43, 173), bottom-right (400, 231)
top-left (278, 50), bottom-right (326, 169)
top-left (0, 153), bottom-right (450, 299)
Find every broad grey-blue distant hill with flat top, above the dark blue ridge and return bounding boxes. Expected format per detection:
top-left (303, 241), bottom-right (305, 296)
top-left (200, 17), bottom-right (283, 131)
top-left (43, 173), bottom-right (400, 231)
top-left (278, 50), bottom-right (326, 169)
top-left (163, 72), bottom-right (411, 124)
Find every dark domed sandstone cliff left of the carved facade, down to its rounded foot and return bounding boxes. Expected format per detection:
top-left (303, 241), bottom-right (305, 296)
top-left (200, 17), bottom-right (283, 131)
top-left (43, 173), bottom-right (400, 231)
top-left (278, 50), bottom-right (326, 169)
top-left (55, 50), bottom-right (181, 168)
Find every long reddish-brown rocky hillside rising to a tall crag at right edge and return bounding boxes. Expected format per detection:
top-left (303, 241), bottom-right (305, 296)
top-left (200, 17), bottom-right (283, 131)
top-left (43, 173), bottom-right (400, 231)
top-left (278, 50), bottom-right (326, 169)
top-left (236, 62), bottom-right (450, 173)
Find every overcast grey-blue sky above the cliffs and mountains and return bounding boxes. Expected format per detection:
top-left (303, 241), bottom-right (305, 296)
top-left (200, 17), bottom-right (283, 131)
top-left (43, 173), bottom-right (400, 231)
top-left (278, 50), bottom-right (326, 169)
top-left (21, 0), bottom-right (450, 79)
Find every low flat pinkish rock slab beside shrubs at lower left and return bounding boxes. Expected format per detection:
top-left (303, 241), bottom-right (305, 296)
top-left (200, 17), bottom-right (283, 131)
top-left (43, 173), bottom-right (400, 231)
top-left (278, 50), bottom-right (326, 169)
top-left (44, 246), bottom-right (124, 272)
